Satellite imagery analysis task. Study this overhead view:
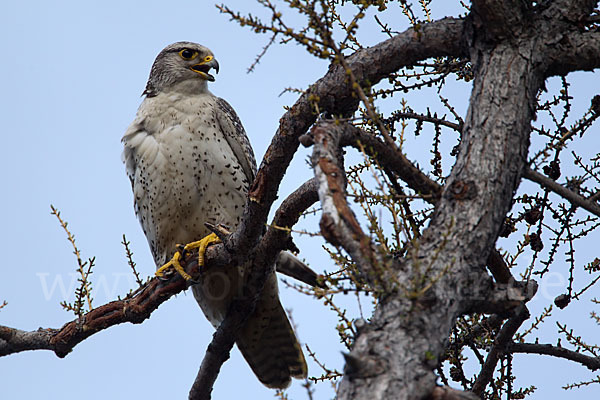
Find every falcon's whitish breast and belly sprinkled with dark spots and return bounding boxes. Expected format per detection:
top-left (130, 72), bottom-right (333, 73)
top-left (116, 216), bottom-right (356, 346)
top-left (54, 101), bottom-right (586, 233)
top-left (123, 88), bottom-right (254, 324)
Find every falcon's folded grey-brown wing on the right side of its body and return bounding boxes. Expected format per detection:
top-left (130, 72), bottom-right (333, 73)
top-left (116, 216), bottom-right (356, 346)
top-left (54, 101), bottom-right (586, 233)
top-left (216, 97), bottom-right (256, 184)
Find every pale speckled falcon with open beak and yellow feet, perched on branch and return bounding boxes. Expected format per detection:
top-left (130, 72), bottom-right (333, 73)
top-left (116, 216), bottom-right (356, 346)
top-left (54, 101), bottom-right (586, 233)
top-left (122, 42), bottom-right (307, 388)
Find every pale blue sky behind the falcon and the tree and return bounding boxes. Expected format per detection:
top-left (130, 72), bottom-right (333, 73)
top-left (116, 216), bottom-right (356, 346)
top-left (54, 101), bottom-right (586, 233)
top-left (0, 0), bottom-right (600, 400)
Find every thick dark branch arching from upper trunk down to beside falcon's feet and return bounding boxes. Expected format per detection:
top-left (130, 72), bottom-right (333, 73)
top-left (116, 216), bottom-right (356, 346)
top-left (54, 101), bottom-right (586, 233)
top-left (228, 18), bottom-right (466, 257)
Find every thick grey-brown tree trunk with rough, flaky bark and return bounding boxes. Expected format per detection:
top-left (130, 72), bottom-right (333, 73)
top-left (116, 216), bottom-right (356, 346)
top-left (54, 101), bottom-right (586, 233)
top-left (338, 0), bottom-right (598, 399)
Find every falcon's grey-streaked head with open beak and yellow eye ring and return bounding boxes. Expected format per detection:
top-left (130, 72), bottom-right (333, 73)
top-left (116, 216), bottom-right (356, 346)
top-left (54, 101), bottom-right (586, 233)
top-left (144, 42), bottom-right (219, 97)
